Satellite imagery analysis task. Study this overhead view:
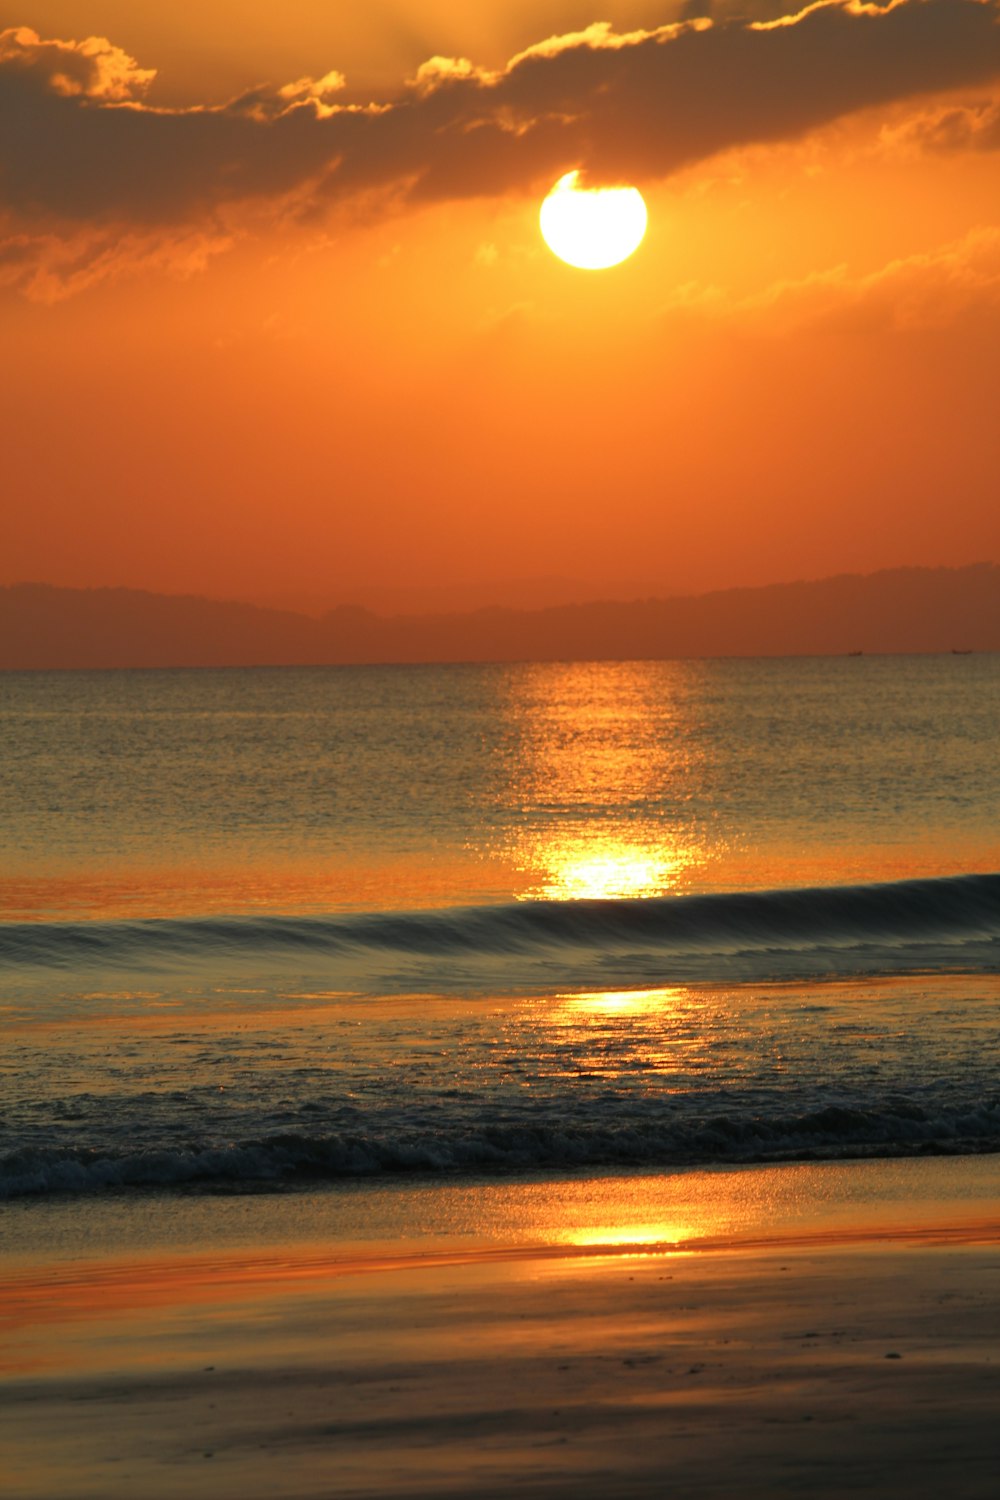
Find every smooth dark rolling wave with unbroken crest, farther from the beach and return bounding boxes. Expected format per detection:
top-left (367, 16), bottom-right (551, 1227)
top-left (0, 875), bottom-right (1000, 993)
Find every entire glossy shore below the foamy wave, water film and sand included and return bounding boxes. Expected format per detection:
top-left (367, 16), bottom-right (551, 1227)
top-left (0, 1134), bottom-right (1000, 1500)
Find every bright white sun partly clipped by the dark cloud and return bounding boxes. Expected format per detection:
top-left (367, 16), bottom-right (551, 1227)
top-left (538, 171), bottom-right (646, 272)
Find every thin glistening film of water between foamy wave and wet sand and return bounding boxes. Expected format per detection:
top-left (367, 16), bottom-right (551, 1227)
top-left (0, 1152), bottom-right (1000, 1277)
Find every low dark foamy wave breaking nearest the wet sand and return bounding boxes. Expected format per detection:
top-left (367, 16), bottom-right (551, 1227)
top-left (0, 1097), bottom-right (1000, 1200)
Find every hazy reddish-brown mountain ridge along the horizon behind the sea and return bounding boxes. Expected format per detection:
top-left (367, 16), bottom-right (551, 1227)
top-left (0, 563), bottom-right (1000, 671)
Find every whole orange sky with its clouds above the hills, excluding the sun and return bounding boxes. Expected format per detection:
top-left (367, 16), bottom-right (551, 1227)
top-left (0, 0), bottom-right (1000, 605)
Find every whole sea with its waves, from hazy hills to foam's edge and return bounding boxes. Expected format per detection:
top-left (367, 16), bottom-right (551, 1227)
top-left (0, 656), bottom-right (1000, 1203)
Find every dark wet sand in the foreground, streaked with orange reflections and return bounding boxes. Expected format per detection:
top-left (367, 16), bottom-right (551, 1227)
top-left (0, 1217), bottom-right (1000, 1500)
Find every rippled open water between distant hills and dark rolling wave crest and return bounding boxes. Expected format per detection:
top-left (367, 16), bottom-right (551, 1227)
top-left (0, 656), bottom-right (1000, 917)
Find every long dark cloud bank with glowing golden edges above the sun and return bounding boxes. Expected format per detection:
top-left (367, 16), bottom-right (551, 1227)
top-left (0, 0), bottom-right (1000, 225)
